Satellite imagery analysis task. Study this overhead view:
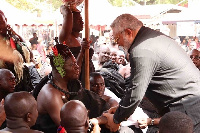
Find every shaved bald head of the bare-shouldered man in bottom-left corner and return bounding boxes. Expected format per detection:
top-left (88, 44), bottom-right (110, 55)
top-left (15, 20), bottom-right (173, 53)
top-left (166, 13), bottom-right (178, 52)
top-left (4, 91), bottom-right (37, 119)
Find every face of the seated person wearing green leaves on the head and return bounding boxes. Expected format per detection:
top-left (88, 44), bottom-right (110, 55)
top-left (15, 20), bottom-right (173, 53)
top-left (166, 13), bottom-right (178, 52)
top-left (64, 56), bottom-right (79, 79)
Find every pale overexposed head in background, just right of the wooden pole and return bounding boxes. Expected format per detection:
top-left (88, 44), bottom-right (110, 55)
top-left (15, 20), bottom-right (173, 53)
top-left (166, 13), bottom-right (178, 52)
top-left (99, 44), bottom-right (110, 65)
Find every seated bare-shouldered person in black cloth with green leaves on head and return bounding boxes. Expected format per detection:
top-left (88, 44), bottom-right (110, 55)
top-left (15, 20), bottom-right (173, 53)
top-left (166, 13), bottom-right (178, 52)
top-left (33, 44), bottom-right (108, 133)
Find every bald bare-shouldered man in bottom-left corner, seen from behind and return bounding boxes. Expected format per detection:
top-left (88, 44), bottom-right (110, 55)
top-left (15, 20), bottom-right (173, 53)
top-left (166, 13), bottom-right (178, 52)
top-left (0, 91), bottom-right (42, 133)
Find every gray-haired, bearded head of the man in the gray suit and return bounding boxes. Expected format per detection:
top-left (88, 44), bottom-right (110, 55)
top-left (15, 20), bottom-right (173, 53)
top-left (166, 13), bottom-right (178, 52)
top-left (110, 14), bottom-right (143, 50)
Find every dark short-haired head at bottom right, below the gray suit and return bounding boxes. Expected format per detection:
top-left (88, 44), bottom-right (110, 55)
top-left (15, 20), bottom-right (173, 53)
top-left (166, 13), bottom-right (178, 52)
top-left (159, 111), bottom-right (193, 133)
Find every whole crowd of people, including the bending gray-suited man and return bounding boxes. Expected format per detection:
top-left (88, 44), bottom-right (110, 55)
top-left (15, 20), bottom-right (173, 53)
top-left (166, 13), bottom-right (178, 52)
top-left (0, 2), bottom-right (200, 133)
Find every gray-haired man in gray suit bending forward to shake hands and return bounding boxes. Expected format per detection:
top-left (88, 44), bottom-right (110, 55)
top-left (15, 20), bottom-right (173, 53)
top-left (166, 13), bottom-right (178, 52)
top-left (104, 14), bottom-right (200, 132)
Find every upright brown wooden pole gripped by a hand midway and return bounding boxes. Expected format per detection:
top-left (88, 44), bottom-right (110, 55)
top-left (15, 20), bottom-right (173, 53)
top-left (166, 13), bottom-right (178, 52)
top-left (85, 0), bottom-right (90, 90)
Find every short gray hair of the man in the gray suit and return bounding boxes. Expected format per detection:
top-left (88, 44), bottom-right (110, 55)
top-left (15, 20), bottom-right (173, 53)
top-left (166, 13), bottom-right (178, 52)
top-left (110, 14), bottom-right (143, 32)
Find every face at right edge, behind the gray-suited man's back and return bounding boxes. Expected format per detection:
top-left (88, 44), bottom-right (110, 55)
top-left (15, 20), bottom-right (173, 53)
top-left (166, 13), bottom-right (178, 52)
top-left (190, 49), bottom-right (200, 69)
